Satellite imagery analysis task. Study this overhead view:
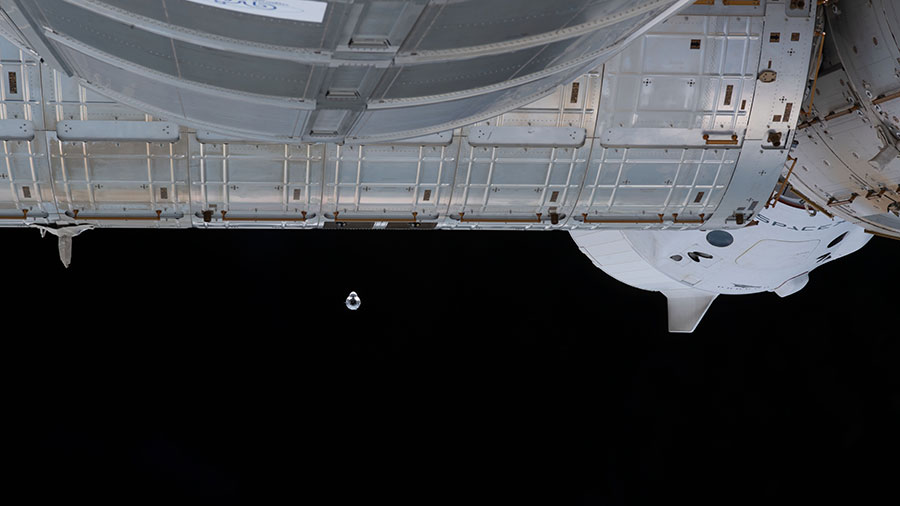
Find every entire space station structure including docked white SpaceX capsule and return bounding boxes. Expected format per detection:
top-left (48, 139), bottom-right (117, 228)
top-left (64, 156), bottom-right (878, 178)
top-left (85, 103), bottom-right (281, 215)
top-left (0, 0), bottom-right (900, 332)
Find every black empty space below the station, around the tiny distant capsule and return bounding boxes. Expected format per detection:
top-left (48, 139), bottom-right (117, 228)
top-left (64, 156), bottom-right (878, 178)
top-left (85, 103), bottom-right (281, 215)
top-left (0, 230), bottom-right (900, 505)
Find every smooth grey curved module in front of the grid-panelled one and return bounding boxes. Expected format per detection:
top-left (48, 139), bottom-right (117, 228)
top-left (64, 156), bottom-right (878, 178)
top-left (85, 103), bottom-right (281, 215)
top-left (3, 0), bottom-right (689, 142)
